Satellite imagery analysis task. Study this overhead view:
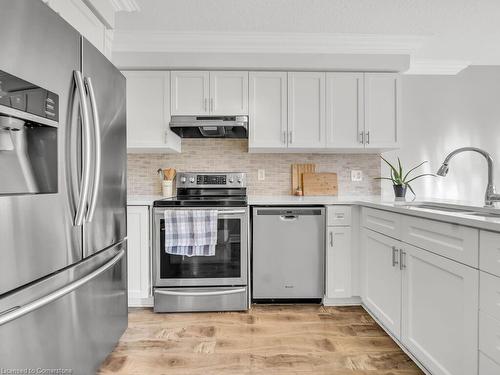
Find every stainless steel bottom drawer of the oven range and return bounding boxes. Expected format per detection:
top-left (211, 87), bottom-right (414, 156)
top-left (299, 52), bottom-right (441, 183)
top-left (154, 286), bottom-right (248, 312)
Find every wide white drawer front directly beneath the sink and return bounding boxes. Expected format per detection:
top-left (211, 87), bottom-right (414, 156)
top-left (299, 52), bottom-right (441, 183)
top-left (402, 216), bottom-right (479, 267)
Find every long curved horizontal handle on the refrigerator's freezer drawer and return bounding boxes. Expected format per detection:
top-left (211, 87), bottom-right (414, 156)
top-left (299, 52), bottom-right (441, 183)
top-left (0, 249), bottom-right (125, 326)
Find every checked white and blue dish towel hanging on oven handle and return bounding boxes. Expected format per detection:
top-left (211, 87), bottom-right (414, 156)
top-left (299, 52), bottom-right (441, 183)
top-left (164, 210), bottom-right (217, 257)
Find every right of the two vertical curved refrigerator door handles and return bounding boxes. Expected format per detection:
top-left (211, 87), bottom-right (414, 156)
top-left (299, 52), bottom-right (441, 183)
top-left (85, 77), bottom-right (102, 222)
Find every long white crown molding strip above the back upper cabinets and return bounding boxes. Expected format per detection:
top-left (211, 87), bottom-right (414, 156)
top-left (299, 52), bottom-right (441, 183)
top-left (113, 30), bottom-right (427, 54)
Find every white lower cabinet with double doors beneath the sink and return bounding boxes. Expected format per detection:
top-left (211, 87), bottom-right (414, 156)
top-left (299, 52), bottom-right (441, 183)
top-left (361, 209), bottom-right (482, 375)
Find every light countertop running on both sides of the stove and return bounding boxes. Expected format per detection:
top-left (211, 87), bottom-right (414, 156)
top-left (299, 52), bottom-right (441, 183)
top-left (127, 195), bottom-right (500, 232)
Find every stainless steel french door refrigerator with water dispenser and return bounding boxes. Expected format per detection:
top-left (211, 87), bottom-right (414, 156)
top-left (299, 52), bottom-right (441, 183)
top-left (0, 0), bottom-right (127, 375)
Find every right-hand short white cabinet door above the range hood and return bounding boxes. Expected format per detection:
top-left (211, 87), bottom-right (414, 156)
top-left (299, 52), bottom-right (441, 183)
top-left (210, 72), bottom-right (248, 115)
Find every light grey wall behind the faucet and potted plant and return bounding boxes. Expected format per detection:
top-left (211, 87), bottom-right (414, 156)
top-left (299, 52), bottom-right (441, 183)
top-left (382, 66), bottom-right (500, 206)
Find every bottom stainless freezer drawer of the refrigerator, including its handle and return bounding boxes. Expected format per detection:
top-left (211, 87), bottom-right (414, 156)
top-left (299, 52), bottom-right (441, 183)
top-left (0, 244), bottom-right (127, 375)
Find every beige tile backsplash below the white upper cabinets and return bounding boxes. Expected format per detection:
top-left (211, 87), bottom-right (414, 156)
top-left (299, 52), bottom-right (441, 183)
top-left (128, 139), bottom-right (380, 195)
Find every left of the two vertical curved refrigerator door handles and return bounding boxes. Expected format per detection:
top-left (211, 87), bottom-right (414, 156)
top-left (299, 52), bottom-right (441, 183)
top-left (73, 70), bottom-right (92, 226)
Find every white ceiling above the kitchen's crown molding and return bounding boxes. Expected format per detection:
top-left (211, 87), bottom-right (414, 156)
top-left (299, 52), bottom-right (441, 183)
top-left (115, 0), bottom-right (500, 69)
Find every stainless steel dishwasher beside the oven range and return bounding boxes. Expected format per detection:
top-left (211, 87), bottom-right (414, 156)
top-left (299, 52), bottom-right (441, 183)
top-left (252, 207), bottom-right (325, 300)
